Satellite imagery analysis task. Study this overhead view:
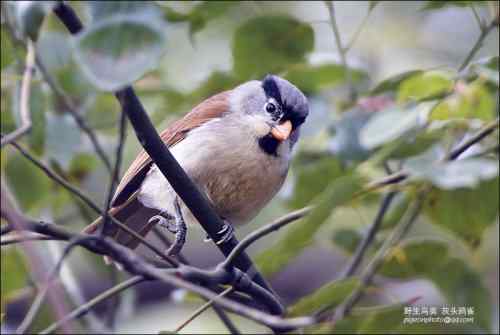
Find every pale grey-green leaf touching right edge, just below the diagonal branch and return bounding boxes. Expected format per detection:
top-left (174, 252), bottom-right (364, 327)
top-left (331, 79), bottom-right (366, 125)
top-left (405, 158), bottom-right (498, 190)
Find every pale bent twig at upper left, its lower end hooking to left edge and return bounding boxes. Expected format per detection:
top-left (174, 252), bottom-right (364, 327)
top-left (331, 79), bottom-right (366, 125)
top-left (0, 40), bottom-right (35, 147)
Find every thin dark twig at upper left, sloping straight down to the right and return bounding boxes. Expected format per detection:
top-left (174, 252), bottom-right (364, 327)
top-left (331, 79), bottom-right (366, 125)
top-left (35, 56), bottom-right (112, 174)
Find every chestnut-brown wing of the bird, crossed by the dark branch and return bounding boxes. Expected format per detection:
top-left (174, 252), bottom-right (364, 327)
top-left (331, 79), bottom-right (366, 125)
top-left (113, 91), bottom-right (230, 207)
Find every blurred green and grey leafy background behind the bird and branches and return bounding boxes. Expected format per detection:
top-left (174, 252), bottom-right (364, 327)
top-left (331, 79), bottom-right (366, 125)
top-left (1, 1), bottom-right (499, 333)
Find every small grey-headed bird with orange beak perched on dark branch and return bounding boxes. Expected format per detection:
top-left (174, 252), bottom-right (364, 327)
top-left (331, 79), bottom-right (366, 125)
top-left (84, 75), bottom-right (309, 255)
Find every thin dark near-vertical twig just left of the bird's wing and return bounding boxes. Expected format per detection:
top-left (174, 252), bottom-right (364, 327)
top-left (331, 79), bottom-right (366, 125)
top-left (100, 113), bottom-right (127, 235)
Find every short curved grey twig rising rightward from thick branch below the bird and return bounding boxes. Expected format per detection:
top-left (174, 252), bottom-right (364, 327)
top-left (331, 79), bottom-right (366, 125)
top-left (221, 207), bottom-right (312, 269)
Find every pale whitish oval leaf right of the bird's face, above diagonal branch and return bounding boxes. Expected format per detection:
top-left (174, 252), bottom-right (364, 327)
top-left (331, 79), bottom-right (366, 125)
top-left (360, 106), bottom-right (422, 150)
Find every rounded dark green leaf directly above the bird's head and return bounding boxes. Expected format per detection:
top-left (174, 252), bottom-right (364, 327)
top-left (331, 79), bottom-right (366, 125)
top-left (232, 16), bottom-right (314, 80)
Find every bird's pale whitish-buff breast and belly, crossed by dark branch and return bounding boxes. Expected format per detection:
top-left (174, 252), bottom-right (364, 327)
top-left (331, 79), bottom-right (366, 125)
top-left (138, 116), bottom-right (290, 228)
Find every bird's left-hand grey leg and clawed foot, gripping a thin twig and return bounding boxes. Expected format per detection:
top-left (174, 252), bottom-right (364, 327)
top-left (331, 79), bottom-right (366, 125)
top-left (148, 197), bottom-right (187, 256)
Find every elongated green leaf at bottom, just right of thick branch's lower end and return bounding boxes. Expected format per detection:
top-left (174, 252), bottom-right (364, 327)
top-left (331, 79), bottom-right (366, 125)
top-left (288, 278), bottom-right (359, 317)
